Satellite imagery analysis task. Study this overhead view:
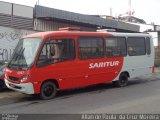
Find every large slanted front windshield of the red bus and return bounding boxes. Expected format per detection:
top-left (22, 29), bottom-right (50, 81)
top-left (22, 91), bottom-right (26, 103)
top-left (8, 38), bottom-right (42, 70)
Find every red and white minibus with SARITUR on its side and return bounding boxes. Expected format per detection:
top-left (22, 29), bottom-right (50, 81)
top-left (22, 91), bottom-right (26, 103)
top-left (5, 28), bottom-right (154, 100)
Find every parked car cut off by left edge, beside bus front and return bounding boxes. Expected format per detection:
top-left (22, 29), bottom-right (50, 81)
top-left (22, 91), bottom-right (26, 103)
top-left (0, 62), bottom-right (7, 90)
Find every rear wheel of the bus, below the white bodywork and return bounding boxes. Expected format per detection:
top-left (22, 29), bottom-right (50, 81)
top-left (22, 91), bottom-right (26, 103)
top-left (113, 73), bottom-right (128, 87)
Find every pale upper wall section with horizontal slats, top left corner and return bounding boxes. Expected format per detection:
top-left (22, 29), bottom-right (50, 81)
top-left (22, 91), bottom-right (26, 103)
top-left (0, 1), bottom-right (33, 30)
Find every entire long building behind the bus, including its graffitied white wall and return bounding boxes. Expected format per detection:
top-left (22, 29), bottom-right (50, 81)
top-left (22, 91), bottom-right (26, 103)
top-left (0, 1), bottom-right (139, 60)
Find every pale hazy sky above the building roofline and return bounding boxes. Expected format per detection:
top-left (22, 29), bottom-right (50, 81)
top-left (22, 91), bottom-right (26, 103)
top-left (2, 0), bottom-right (160, 25)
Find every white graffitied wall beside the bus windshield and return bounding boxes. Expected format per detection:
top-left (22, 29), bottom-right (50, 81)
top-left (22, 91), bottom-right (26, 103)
top-left (0, 26), bottom-right (35, 61)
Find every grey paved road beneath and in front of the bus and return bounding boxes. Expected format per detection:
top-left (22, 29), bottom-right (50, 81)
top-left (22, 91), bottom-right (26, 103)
top-left (0, 68), bottom-right (160, 114)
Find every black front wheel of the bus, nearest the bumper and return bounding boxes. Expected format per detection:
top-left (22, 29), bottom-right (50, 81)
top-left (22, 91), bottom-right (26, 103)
top-left (40, 81), bottom-right (57, 100)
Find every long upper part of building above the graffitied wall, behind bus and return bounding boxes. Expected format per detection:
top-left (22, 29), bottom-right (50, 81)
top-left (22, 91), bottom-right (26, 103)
top-left (0, 1), bottom-right (139, 32)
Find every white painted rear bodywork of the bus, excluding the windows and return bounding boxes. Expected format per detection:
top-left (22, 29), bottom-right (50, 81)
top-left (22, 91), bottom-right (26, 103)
top-left (111, 33), bottom-right (155, 81)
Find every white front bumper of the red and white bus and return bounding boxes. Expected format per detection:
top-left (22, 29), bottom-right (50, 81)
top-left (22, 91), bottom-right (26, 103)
top-left (5, 79), bottom-right (34, 94)
